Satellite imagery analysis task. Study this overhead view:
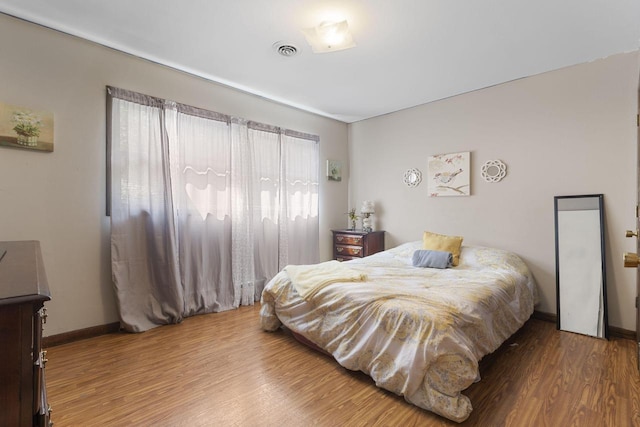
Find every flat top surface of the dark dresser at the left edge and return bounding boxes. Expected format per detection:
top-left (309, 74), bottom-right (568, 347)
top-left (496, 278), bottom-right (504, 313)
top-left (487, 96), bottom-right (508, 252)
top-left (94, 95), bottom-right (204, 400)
top-left (0, 240), bottom-right (51, 305)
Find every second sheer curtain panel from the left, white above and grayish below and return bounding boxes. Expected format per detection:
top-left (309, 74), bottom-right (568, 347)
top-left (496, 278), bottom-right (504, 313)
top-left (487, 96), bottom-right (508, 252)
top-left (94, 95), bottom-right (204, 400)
top-left (168, 104), bottom-right (238, 316)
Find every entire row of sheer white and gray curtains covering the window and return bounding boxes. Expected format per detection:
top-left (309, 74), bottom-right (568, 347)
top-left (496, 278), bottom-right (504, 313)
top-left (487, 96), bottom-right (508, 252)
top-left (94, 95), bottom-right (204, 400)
top-left (108, 88), bottom-right (319, 331)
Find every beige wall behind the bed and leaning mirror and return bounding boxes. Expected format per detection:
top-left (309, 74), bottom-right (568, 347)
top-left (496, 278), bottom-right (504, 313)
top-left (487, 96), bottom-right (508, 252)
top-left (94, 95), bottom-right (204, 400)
top-left (349, 52), bottom-right (638, 330)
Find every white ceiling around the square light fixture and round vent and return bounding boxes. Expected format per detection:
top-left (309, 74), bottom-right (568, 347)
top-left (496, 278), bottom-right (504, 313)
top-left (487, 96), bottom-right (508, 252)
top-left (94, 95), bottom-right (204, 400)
top-left (0, 0), bottom-right (640, 123)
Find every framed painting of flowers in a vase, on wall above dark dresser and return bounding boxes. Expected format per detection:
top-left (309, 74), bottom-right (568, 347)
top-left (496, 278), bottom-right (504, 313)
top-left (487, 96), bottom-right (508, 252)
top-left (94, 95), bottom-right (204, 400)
top-left (0, 102), bottom-right (53, 151)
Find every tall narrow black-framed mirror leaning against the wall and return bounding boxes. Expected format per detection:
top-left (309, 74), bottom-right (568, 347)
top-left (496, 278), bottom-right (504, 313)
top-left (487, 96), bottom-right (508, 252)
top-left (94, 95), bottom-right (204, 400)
top-left (554, 194), bottom-right (609, 338)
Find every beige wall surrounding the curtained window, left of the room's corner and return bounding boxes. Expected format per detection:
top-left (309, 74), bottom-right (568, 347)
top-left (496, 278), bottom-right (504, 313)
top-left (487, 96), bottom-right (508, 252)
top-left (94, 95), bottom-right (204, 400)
top-left (0, 15), bottom-right (348, 335)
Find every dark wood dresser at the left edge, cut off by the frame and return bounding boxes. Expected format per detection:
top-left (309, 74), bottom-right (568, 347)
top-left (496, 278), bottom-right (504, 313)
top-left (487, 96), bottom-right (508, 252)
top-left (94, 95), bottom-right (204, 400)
top-left (0, 241), bottom-right (52, 427)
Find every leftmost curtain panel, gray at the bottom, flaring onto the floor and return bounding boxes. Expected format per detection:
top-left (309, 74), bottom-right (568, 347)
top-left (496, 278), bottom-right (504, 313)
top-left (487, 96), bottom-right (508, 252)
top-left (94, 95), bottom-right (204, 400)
top-left (109, 89), bottom-right (183, 332)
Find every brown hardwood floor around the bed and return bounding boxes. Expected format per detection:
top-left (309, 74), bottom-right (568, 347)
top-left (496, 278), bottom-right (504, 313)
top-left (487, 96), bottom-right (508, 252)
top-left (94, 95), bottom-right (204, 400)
top-left (46, 305), bottom-right (640, 427)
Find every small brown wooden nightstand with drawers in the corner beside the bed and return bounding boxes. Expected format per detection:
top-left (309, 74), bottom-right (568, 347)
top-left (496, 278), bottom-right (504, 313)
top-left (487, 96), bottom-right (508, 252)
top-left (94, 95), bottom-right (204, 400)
top-left (331, 230), bottom-right (384, 261)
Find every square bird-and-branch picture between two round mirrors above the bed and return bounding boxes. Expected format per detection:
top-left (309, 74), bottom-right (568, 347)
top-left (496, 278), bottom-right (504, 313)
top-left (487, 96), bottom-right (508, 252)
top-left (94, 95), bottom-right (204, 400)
top-left (427, 151), bottom-right (471, 197)
